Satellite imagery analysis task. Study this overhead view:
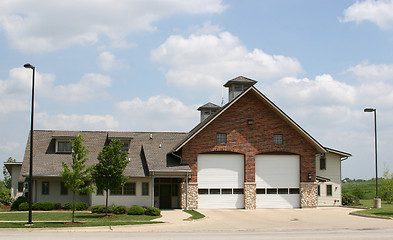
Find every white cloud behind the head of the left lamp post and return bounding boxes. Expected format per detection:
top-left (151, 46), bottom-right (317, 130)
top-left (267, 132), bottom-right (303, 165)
top-left (0, 68), bottom-right (112, 114)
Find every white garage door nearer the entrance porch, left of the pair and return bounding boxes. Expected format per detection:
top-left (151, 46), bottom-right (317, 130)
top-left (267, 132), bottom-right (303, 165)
top-left (198, 154), bottom-right (244, 209)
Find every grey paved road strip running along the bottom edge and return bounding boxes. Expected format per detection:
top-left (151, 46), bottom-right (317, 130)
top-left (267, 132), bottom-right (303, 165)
top-left (0, 229), bottom-right (393, 240)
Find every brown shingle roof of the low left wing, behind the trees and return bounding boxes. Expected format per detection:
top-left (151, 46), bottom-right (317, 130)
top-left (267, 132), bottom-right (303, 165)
top-left (21, 130), bottom-right (189, 177)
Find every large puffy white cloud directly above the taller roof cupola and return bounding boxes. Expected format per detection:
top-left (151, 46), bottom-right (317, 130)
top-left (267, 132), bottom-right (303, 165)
top-left (151, 32), bottom-right (303, 89)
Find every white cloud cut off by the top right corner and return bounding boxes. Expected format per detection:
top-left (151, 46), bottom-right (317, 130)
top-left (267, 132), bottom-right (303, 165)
top-left (341, 0), bottom-right (393, 29)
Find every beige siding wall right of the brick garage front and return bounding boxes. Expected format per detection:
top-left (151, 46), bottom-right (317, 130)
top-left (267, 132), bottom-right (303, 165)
top-left (316, 153), bottom-right (341, 206)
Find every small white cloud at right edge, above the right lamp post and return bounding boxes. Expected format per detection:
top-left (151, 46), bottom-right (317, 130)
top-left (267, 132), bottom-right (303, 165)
top-left (346, 63), bottom-right (393, 82)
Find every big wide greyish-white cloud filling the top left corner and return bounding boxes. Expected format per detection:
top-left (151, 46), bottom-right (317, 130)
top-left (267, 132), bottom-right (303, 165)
top-left (0, 0), bottom-right (225, 52)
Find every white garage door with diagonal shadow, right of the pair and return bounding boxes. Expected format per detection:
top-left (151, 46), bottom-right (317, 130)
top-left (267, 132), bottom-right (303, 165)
top-left (255, 155), bottom-right (300, 208)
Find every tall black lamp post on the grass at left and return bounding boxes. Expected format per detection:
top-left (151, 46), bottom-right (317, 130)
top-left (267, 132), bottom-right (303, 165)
top-left (24, 63), bottom-right (35, 225)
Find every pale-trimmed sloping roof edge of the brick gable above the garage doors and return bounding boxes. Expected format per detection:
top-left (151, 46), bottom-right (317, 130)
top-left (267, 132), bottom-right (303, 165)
top-left (172, 86), bottom-right (327, 153)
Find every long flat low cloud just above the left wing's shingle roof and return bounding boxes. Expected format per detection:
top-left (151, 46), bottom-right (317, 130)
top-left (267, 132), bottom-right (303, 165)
top-left (36, 113), bottom-right (119, 130)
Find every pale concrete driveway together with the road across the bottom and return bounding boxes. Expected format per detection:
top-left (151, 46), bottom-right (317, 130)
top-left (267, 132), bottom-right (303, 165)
top-left (0, 207), bottom-right (393, 240)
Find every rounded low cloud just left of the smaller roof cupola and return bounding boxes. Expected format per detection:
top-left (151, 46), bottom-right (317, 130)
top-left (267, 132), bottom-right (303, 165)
top-left (116, 95), bottom-right (199, 131)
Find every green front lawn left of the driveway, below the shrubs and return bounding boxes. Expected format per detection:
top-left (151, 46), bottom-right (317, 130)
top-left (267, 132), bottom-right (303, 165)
top-left (0, 212), bottom-right (159, 228)
